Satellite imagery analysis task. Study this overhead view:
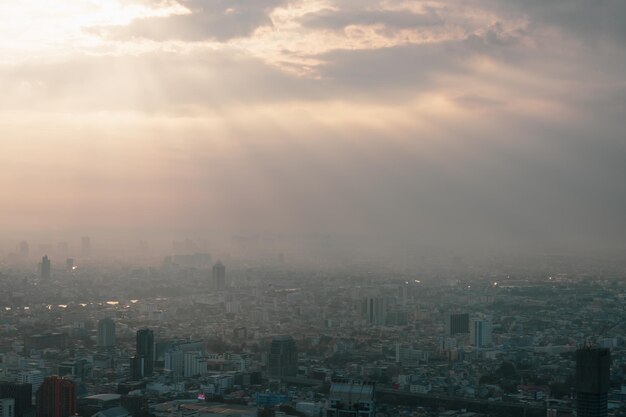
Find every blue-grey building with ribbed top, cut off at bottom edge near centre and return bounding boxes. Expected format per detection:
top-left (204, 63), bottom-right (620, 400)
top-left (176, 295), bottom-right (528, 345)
top-left (323, 379), bottom-right (376, 417)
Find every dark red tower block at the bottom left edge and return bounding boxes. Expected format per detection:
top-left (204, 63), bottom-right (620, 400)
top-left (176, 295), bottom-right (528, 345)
top-left (36, 376), bottom-right (76, 417)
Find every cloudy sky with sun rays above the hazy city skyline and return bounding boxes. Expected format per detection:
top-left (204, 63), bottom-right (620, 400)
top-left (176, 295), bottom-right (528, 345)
top-left (0, 0), bottom-right (626, 255)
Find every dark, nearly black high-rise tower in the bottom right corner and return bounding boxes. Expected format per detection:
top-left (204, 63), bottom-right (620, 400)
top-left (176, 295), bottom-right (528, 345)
top-left (576, 348), bottom-right (611, 417)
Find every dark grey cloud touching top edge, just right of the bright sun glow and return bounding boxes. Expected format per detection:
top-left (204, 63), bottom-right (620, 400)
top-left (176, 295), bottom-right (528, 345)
top-left (97, 0), bottom-right (285, 42)
